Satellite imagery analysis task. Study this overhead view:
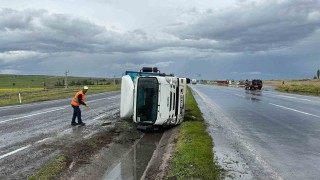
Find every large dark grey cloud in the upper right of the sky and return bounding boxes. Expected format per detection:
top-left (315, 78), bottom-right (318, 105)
top-left (170, 0), bottom-right (320, 52)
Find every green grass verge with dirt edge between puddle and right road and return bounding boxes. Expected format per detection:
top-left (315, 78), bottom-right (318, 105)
top-left (143, 86), bottom-right (223, 179)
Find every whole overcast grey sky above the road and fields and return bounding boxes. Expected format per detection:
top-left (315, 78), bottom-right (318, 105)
top-left (0, 0), bottom-right (320, 79)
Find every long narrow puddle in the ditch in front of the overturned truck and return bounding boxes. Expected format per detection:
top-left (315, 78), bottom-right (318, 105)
top-left (102, 132), bottom-right (163, 180)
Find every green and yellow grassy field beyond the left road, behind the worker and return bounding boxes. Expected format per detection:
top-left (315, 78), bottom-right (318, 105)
top-left (0, 75), bottom-right (120, 106)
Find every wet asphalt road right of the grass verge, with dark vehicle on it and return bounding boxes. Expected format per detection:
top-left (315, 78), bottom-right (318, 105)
top-left (191, 84), bottom-right (320, 179)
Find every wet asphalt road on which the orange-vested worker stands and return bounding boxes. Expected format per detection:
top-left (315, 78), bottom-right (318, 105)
top-left (0, 91), bottom-right (120, 179)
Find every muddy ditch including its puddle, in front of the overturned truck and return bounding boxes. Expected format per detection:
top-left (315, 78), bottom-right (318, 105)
top-left (29, 118), bottom-right (178, 180)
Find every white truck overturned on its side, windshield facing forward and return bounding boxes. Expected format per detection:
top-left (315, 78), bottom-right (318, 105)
top-left (120, 67), bottom-right (190, 129)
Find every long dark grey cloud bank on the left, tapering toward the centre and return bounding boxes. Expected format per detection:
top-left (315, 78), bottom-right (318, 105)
top-left (0, 9), bottom-right (179, 53)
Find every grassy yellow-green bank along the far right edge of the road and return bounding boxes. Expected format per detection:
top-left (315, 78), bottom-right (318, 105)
top-left (263, 79), bottom-right (320, 96)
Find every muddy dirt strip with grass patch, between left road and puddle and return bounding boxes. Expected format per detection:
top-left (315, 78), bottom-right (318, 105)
top-left (29, 121), bottom-right (143, 179)
